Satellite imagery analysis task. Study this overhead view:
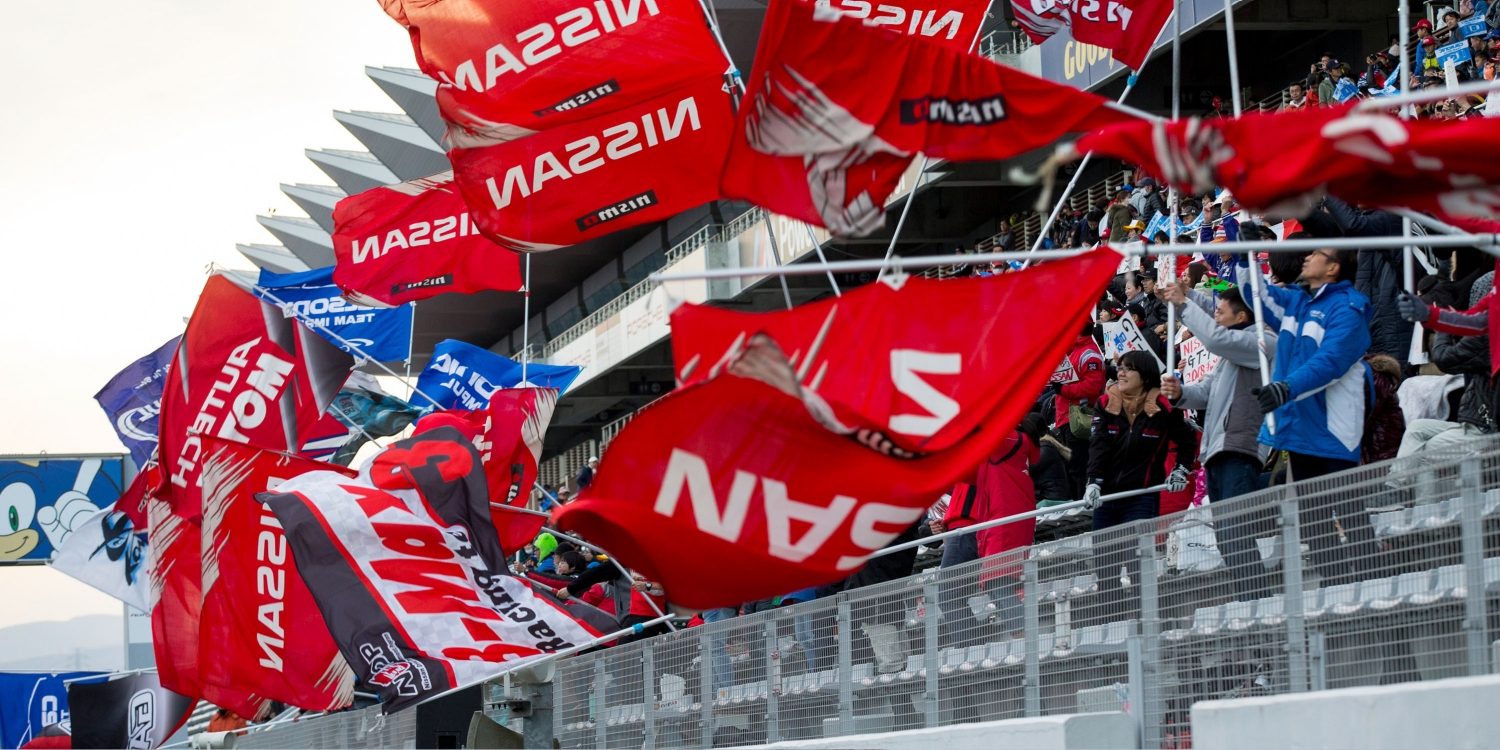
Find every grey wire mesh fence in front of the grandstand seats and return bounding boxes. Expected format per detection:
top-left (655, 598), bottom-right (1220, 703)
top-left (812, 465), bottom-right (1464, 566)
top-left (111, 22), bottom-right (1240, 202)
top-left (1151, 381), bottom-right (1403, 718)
top-left (231, 437), bottom-right (1500, 749)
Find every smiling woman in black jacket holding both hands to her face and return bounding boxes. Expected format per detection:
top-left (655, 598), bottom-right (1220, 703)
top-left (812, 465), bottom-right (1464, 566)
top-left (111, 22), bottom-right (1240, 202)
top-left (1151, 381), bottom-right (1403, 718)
top-left (1083, 351), bottom-right (1197, 621)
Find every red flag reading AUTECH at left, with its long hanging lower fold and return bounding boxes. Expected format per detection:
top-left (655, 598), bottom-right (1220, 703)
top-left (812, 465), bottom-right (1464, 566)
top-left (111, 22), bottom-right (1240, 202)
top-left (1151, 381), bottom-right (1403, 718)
top-left (149, 275), bottom-right (354, 701)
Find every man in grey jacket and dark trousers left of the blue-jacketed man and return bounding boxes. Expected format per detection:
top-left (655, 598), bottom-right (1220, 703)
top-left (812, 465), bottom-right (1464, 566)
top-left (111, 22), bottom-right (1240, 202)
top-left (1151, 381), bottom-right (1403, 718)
top-left (1161, 287), bottom-right (1277, 602)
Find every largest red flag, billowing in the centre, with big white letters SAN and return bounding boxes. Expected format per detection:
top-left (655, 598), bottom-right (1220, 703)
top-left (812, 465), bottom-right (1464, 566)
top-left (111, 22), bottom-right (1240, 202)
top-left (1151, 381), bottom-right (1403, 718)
top-left (557, 252), bottom-right (1119, 608)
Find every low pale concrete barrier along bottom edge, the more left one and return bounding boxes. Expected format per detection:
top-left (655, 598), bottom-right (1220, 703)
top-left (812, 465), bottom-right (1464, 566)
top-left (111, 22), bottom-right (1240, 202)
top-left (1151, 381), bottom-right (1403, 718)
top-left (729, 713), bottom-right (1139, 750)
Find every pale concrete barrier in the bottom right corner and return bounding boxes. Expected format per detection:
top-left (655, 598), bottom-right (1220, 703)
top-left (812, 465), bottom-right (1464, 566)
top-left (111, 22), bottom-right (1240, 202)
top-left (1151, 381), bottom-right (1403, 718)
top-left (1193, 675), bottom-right (1500, 750)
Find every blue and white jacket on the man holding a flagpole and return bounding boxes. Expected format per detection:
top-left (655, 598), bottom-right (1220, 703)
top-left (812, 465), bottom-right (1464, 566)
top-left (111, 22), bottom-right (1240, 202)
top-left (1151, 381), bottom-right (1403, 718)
top-left (1239, 266), bottom-right (1371, 462)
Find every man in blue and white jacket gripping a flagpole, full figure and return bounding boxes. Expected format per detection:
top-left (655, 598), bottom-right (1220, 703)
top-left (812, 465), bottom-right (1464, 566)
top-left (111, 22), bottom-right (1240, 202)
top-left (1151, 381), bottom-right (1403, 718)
top-left (1241, 249), bottom-right (1376, 582)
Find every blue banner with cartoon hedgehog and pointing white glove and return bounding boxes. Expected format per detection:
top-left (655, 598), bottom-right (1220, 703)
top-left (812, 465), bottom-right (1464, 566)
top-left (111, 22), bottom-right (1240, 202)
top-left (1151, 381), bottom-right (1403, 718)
top-left (0, 456), bottom-right (125, 564)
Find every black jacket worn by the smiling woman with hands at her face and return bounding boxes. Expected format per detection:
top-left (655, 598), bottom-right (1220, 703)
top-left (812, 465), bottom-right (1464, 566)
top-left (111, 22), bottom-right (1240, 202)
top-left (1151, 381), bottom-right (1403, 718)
top-left (1089, 387), bottom-right (1199, 495)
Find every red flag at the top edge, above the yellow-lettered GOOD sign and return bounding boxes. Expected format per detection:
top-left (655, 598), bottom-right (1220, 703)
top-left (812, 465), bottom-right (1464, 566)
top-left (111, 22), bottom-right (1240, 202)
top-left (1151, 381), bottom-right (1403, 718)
top-left (1011, 0), bottom-right (1173, 71)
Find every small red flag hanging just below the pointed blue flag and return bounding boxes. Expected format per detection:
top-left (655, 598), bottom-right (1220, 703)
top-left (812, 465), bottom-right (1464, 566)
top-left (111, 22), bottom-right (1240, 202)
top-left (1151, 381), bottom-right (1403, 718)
top-left (417, 389), bottom-right (558, 552)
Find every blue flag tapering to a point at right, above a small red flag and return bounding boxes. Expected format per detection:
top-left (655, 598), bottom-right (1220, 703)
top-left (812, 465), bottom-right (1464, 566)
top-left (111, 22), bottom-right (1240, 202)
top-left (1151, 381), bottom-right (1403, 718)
top-left (416, 339), bottom-right (582, 411)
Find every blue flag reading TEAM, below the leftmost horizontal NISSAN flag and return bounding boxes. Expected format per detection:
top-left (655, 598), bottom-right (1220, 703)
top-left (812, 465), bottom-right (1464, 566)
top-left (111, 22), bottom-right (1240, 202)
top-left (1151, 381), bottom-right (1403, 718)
top-left (255, 266), bottom-right (411, 362)
